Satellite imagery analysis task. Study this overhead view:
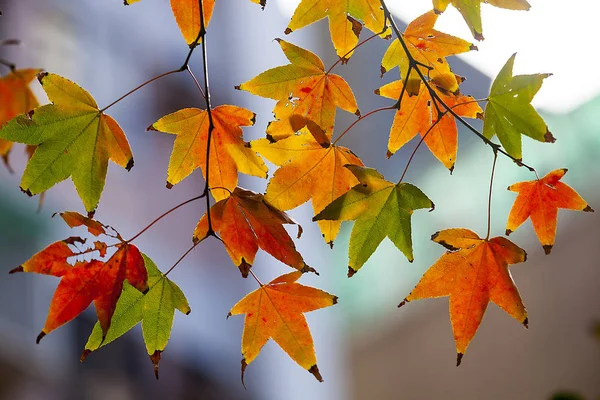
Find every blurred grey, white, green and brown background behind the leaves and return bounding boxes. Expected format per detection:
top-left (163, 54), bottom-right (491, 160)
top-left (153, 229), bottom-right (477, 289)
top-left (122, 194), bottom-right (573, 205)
top-left (0, 0), bottom-right (600, 400)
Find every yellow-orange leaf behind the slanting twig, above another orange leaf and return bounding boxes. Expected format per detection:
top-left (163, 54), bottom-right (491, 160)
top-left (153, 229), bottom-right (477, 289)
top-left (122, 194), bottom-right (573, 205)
top-left (381, 11), bottom-right (477, 95)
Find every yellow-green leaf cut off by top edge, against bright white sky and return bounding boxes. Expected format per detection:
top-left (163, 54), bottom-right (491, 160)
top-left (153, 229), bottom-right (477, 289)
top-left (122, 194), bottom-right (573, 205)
top-left (433, 0), bottom-right (531, 40)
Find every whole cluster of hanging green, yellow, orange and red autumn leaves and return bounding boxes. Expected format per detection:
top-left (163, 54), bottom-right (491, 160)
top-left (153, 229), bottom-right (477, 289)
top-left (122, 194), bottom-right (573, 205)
top-left (0, 0), bottom-right (593, 380)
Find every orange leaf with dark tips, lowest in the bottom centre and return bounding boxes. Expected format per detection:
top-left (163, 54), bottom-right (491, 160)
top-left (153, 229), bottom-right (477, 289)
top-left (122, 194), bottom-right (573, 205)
top-left (227, 271), bottom-right (337, 382)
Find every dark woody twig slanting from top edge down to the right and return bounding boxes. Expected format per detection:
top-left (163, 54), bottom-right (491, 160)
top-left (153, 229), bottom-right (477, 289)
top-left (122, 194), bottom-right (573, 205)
top-left (380, 0), bottom-right (537, 175)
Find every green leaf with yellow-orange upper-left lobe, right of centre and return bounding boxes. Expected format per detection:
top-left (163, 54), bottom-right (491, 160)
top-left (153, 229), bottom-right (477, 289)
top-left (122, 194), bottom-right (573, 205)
top-left (313, 165), bottom-right (435, 277)
